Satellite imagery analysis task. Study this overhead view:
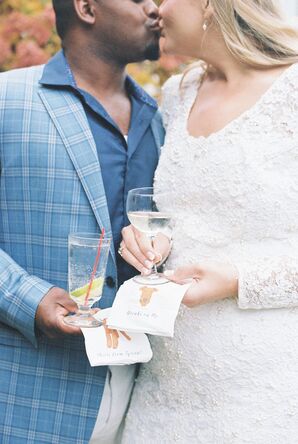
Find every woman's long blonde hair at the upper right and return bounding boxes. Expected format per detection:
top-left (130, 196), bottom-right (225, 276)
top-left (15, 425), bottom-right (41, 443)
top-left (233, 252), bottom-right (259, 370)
top-left (209, 0), bottom-right (298, 68)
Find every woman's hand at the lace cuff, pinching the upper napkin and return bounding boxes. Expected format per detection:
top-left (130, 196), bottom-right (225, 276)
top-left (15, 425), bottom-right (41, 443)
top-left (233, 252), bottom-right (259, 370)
top-left (165, 261), bottom-right (238, 307)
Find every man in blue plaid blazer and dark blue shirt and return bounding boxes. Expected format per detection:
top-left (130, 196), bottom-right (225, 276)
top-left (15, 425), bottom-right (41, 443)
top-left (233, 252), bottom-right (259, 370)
top-left (0, 0), bottom-right (163, 444)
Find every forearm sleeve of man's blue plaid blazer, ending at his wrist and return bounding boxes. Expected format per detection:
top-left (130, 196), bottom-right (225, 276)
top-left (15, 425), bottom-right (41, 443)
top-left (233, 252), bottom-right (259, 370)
top-left (0, 249), bottom-right (53, 347)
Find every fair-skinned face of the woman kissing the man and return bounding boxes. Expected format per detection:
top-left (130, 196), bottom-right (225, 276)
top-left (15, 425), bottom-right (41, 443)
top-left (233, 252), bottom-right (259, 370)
top-left (159, 0), bottom-right (206, 57)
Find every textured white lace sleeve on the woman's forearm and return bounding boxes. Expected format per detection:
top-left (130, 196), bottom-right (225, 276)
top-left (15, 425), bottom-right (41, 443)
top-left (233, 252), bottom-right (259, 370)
top-left (238, 256), bottom-right (298, 309)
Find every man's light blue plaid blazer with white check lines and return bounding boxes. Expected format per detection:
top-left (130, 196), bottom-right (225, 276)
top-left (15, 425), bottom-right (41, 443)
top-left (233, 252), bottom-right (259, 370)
top-left (0, 66), bottom-right (163, 444)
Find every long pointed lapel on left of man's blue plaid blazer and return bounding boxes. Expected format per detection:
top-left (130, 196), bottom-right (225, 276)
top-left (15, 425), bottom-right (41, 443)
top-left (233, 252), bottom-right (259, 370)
top-left (39, 87), bottom-right (115, 261)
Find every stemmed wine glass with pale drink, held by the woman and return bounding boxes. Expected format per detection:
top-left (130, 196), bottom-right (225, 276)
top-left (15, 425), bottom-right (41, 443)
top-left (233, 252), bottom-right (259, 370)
top-left (126, 187), bottom-right (172, 285)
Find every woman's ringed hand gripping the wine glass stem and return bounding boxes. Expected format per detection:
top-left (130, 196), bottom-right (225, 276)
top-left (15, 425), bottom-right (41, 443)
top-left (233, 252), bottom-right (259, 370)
top-left (118, 225), bottom-right (171, 275)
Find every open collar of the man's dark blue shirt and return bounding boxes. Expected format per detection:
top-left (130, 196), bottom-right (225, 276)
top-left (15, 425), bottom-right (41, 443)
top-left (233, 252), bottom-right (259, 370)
top-left (40, 50), bottom-right (157, 109)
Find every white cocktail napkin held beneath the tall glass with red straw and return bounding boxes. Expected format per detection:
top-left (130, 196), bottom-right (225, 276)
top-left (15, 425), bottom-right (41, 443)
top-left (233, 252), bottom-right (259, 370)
top-left (82, 308), bottom-right (152, 367)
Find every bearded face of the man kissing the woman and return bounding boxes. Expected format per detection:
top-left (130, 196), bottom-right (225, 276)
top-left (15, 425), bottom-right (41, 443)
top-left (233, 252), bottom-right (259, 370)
top-left (94, 0), bottom-right (160, 64)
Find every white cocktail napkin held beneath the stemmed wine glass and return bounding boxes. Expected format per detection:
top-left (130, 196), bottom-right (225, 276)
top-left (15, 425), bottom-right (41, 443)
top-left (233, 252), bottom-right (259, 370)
top-left (108, 279), bottom-right (191, 337)
